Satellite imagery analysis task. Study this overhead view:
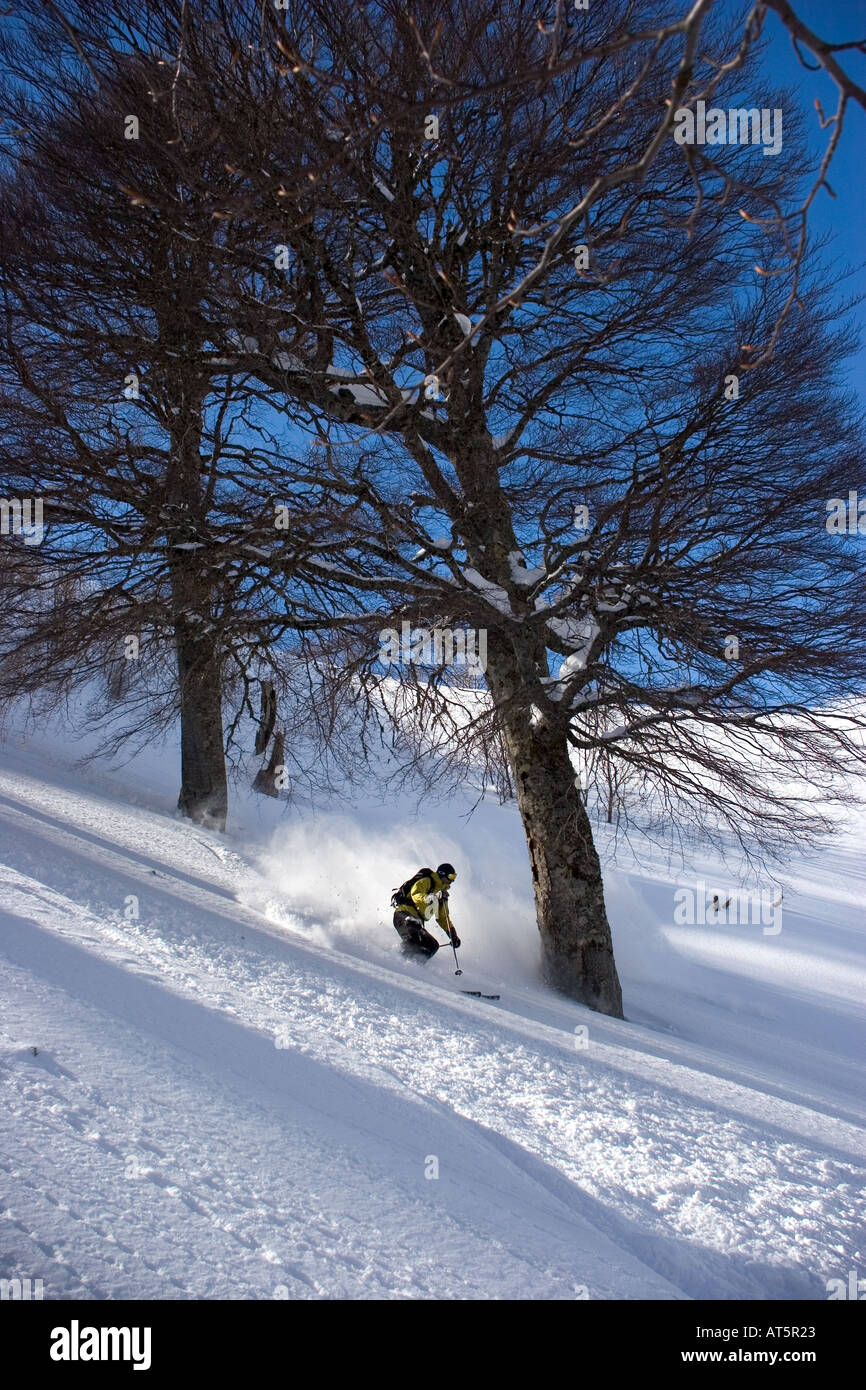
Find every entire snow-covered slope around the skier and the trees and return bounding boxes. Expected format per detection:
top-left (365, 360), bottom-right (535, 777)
top-left (0, 739), bottom-right (866, 1300)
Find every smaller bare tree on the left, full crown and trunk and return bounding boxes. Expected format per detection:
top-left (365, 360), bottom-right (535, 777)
top-left (0, 27), bottom-right (347, 828)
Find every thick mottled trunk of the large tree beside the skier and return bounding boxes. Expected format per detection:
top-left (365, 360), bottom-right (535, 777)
top-left (487, 634), bottom-right (623, 1019)
